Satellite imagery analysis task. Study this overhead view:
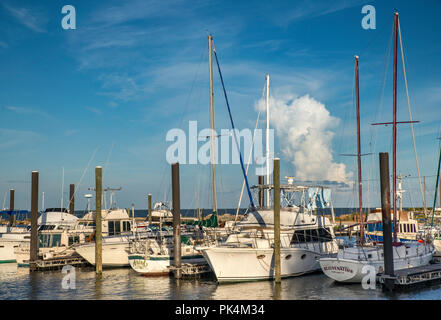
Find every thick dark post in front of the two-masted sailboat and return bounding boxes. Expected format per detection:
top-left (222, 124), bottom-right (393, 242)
top-left (380, 152), bottom-right (394, 291)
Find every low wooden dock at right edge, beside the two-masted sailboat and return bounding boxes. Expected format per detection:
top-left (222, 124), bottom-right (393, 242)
top-left (377, 263), bottom-right (441, 289)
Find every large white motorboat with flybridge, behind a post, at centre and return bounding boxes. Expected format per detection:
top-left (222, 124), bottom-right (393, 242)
top-left (201, 185), bottom-right (338, 282)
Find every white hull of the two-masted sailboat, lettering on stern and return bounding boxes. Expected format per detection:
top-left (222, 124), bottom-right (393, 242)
top-left (320, 245), bottom-right (434, 283)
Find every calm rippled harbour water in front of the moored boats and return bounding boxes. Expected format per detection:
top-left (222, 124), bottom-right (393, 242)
top-left (0, 264), bottom-right (441, 300)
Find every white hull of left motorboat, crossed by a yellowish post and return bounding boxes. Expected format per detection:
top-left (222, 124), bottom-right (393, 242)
top-left (75, 242), bottom-right (129, 267)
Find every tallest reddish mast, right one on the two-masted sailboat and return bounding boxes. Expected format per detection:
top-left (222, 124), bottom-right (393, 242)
top-left (393, 12), bottom-right (398, 243)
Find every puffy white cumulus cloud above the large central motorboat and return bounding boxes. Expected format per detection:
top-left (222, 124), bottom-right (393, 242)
top-left (256, 95), bottom-right (352, 184)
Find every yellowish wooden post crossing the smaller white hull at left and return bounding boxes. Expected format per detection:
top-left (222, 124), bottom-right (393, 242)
top-left (95, 166), bottom-right (103, 275)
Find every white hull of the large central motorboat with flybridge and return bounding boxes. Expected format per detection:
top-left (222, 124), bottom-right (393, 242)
top-left (202, 247), bottom-right (332, 282)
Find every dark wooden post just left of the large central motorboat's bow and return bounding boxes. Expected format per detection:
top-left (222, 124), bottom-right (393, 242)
top-left (172, 162), bottom-right (182, 279)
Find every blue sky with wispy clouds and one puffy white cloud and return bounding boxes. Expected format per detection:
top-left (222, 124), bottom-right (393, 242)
top-left (0, 0), bottom-right (441, 210)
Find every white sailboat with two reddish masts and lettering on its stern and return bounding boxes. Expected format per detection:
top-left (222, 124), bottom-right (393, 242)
top-left (320, 13), bottom-right (434, 283)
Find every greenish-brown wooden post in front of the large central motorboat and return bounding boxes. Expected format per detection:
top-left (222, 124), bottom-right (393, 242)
top-left (273, 158), bottom-right (281, 283)
